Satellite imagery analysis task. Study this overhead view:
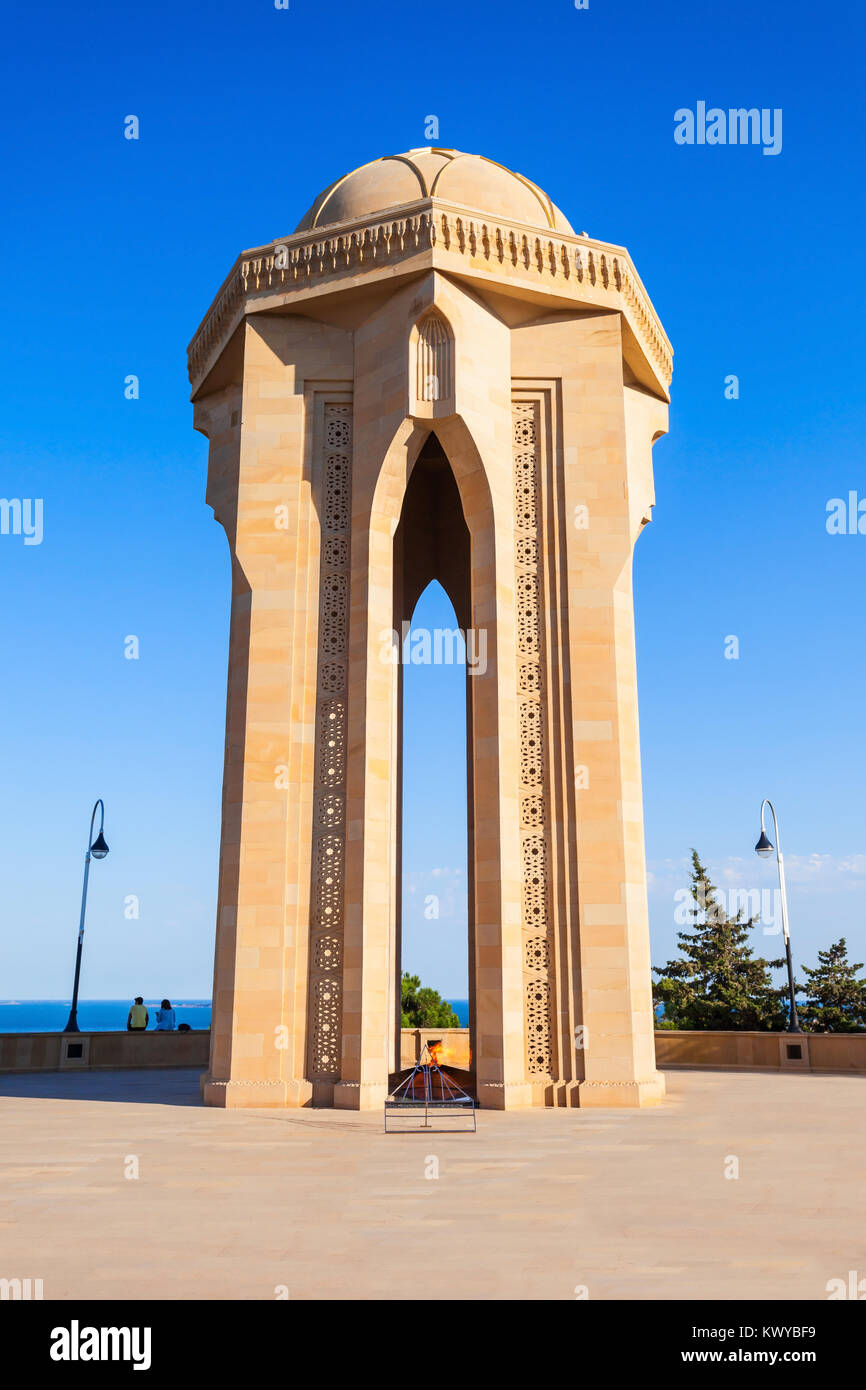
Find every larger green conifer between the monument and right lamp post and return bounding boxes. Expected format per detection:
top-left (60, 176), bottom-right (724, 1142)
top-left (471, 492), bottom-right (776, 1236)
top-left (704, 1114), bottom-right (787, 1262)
top-left (653, 849), bottom-right (787, 1031)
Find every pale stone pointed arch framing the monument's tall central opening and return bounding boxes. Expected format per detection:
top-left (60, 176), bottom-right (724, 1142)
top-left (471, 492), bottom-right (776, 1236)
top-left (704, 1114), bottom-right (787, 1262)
top-left (335, 414), bottom-right (523, 1105)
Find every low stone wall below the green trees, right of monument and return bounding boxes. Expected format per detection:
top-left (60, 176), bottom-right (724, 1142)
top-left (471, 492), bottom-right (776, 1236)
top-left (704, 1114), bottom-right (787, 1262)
top-left (656, 1029), bottom-right (866, 1074)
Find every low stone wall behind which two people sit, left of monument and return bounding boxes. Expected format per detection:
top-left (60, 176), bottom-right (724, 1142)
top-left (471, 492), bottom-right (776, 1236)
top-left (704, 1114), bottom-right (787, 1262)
top-left (0, 1029), bottom-right (210, 1072)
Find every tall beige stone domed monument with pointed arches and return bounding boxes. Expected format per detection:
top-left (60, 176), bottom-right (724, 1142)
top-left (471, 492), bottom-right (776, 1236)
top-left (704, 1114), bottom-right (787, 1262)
top-left (189, 147), bottom-right (671, 1109)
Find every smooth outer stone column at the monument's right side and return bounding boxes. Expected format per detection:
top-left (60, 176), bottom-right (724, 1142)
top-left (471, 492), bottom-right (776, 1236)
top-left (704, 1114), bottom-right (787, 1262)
top-left (563, 316), bottom-right (664, 1105)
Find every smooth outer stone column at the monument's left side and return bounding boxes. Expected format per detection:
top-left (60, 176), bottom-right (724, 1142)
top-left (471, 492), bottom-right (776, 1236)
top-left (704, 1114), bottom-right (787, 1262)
top-left (200, 324), bottom-right (318, 1106)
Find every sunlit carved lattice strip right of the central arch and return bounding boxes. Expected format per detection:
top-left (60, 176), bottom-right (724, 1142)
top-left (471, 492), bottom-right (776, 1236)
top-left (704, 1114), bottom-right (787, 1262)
top-left (513, 402), bottom-right (553, 1077)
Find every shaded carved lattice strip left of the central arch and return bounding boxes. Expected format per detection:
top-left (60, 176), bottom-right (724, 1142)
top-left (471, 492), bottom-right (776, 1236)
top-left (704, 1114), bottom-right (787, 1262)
top-left (309, 403), bottom-right (352, 1079)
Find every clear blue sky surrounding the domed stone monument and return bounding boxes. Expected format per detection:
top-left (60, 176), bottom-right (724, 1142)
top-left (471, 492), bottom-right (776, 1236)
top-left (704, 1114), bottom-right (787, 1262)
top-left (0, 0), bottom-right (866, 998)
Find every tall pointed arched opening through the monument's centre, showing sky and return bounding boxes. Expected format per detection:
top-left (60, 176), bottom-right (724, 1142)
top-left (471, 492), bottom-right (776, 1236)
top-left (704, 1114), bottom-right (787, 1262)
top-left (393, 434), bottom-right (478, 1070)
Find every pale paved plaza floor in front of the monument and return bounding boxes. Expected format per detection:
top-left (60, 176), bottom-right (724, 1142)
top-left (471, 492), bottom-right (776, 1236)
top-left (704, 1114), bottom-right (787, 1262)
top-left (0, 1070), bottom-right (866, 1300)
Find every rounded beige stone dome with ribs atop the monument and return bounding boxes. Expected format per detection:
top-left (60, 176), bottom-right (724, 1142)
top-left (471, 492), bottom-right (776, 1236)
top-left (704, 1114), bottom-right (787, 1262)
top-left (295, 145), bottom-right (574, 234)
